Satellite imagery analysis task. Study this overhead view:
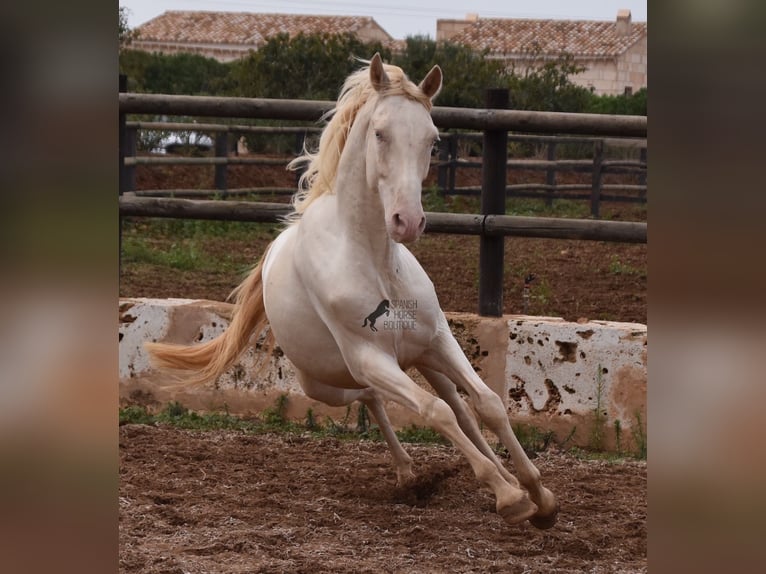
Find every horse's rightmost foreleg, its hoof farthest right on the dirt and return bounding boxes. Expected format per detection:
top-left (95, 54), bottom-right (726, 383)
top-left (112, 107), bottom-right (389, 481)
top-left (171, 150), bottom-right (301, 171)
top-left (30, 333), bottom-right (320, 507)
top-left (427, 336), bottom-right (559, 528)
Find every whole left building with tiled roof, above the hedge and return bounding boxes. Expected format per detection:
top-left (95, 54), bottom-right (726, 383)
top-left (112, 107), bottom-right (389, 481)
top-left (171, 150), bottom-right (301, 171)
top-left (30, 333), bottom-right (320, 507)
top-left (131, 10), bottom-right (393, 62)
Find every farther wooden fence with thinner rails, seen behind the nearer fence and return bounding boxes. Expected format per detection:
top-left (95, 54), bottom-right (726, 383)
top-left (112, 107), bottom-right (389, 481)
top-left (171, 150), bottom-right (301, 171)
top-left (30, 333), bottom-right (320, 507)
top-left (125, 121), bottom-right (646, 217)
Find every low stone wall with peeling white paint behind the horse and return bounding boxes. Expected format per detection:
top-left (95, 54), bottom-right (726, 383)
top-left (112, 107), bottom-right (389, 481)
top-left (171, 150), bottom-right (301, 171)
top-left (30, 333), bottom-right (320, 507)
top-left (119, 299), bottom-right (647, 450)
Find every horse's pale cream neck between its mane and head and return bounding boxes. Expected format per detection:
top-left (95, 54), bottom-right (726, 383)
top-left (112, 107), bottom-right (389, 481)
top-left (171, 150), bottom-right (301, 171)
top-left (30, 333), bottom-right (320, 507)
top-left (335, 105), bottom-right (393, 259)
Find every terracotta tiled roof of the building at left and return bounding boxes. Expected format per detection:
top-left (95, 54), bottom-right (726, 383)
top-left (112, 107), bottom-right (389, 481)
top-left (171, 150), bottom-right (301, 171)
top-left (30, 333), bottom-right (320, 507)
top-left (137, 10), bottom-right (390, 45)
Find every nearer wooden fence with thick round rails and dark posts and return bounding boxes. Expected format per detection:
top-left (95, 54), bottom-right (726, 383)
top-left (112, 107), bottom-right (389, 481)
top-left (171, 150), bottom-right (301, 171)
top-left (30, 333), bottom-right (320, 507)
top-left (119, 89), bottom-right (647, 316)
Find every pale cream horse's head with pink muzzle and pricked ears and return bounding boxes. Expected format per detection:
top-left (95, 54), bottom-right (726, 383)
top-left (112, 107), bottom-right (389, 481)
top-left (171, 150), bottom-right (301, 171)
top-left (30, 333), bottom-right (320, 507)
top-left (367, 54), bottom-right (442, 243)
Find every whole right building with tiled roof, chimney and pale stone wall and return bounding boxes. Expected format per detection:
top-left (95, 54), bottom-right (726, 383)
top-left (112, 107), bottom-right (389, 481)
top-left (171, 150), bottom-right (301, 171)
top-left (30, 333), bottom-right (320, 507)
top-left (436, 10), bottom-right (647, 95)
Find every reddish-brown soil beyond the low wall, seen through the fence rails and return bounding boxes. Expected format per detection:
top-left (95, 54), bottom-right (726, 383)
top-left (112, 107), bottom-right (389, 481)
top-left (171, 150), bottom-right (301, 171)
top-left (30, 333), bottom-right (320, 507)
top-left (120, 158), bottom-right (647, 324)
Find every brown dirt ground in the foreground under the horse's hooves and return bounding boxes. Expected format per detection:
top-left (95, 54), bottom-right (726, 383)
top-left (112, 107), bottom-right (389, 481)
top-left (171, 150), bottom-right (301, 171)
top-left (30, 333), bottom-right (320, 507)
top-left (119, 425), bottom-right (647, 574)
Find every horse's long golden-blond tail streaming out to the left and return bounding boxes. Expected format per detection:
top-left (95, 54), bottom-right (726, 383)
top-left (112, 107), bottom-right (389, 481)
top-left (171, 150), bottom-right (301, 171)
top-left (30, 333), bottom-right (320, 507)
top-left (144, 245), bottom-right (274, 386)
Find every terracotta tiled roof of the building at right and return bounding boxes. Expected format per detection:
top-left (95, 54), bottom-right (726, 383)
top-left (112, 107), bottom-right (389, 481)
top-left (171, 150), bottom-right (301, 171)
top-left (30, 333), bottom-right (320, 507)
top-left (449, 18), bottom-right (647, 57)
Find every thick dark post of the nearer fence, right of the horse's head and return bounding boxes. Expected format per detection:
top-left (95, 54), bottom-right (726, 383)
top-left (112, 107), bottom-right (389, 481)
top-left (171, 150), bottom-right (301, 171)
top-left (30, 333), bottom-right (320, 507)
top-left (479, 88), bottom-right (509, 317)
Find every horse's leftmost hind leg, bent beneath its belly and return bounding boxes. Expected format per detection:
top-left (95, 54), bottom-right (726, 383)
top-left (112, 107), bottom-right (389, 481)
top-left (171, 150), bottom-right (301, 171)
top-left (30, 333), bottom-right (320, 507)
top-left (298, 371), bottom-right (415, 484)
